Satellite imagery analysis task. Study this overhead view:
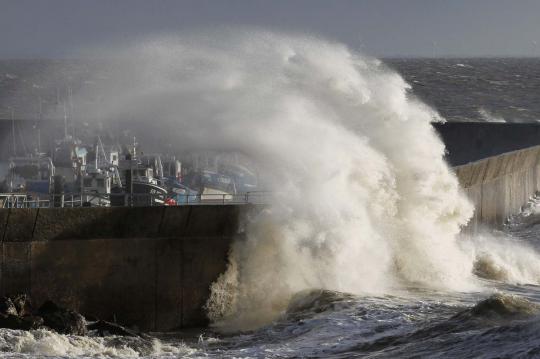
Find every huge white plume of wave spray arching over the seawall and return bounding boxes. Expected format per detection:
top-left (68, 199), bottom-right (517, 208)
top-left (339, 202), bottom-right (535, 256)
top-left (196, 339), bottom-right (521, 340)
top-left (64, 31), bottom-right (486, 329)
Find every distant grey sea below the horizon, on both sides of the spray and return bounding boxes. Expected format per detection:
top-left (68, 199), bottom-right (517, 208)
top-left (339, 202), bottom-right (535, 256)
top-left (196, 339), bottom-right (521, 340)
top-left (0, 58), bottom-right (540, 122)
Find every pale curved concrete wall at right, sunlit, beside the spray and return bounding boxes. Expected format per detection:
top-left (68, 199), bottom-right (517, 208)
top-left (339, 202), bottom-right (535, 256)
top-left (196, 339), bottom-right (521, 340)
top-left (455, 146), bottom-right (540, 232)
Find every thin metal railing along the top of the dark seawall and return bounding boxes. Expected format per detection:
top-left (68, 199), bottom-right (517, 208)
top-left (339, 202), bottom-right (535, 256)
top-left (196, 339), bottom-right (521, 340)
top-left (0, 191), bottom-right (270, 208)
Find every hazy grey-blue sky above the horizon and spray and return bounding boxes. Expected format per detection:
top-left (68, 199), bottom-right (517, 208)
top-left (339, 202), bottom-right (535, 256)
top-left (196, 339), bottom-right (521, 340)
top-left (0, 0), bottom-right (540, 59)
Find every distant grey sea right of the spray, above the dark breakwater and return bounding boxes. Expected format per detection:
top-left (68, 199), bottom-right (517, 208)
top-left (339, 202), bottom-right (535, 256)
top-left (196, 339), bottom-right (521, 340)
top-left (386, 58), bottom-right (540, 122)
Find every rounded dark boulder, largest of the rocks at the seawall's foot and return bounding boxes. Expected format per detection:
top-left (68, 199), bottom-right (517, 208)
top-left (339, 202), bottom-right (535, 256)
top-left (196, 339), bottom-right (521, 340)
top-left (38, 301), bottom-right (88, 335)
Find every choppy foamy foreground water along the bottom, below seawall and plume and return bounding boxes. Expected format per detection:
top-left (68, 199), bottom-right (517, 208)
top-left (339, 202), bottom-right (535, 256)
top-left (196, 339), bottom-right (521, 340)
top-left (0, 282), bottom-right (540, 358)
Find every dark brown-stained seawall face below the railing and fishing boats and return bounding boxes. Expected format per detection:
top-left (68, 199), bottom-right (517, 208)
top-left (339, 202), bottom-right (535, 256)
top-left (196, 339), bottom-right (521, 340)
top-left (0, 205), bottom-right (250, 331)
